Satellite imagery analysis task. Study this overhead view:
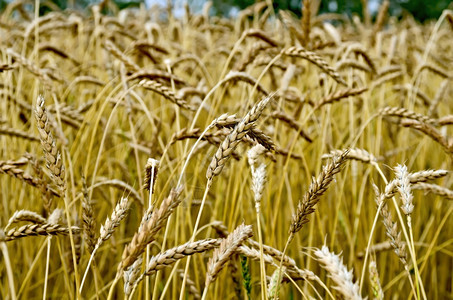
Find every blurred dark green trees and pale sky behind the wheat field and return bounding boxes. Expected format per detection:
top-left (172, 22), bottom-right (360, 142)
top-left (0, 0), bottom-right (453, 22)
